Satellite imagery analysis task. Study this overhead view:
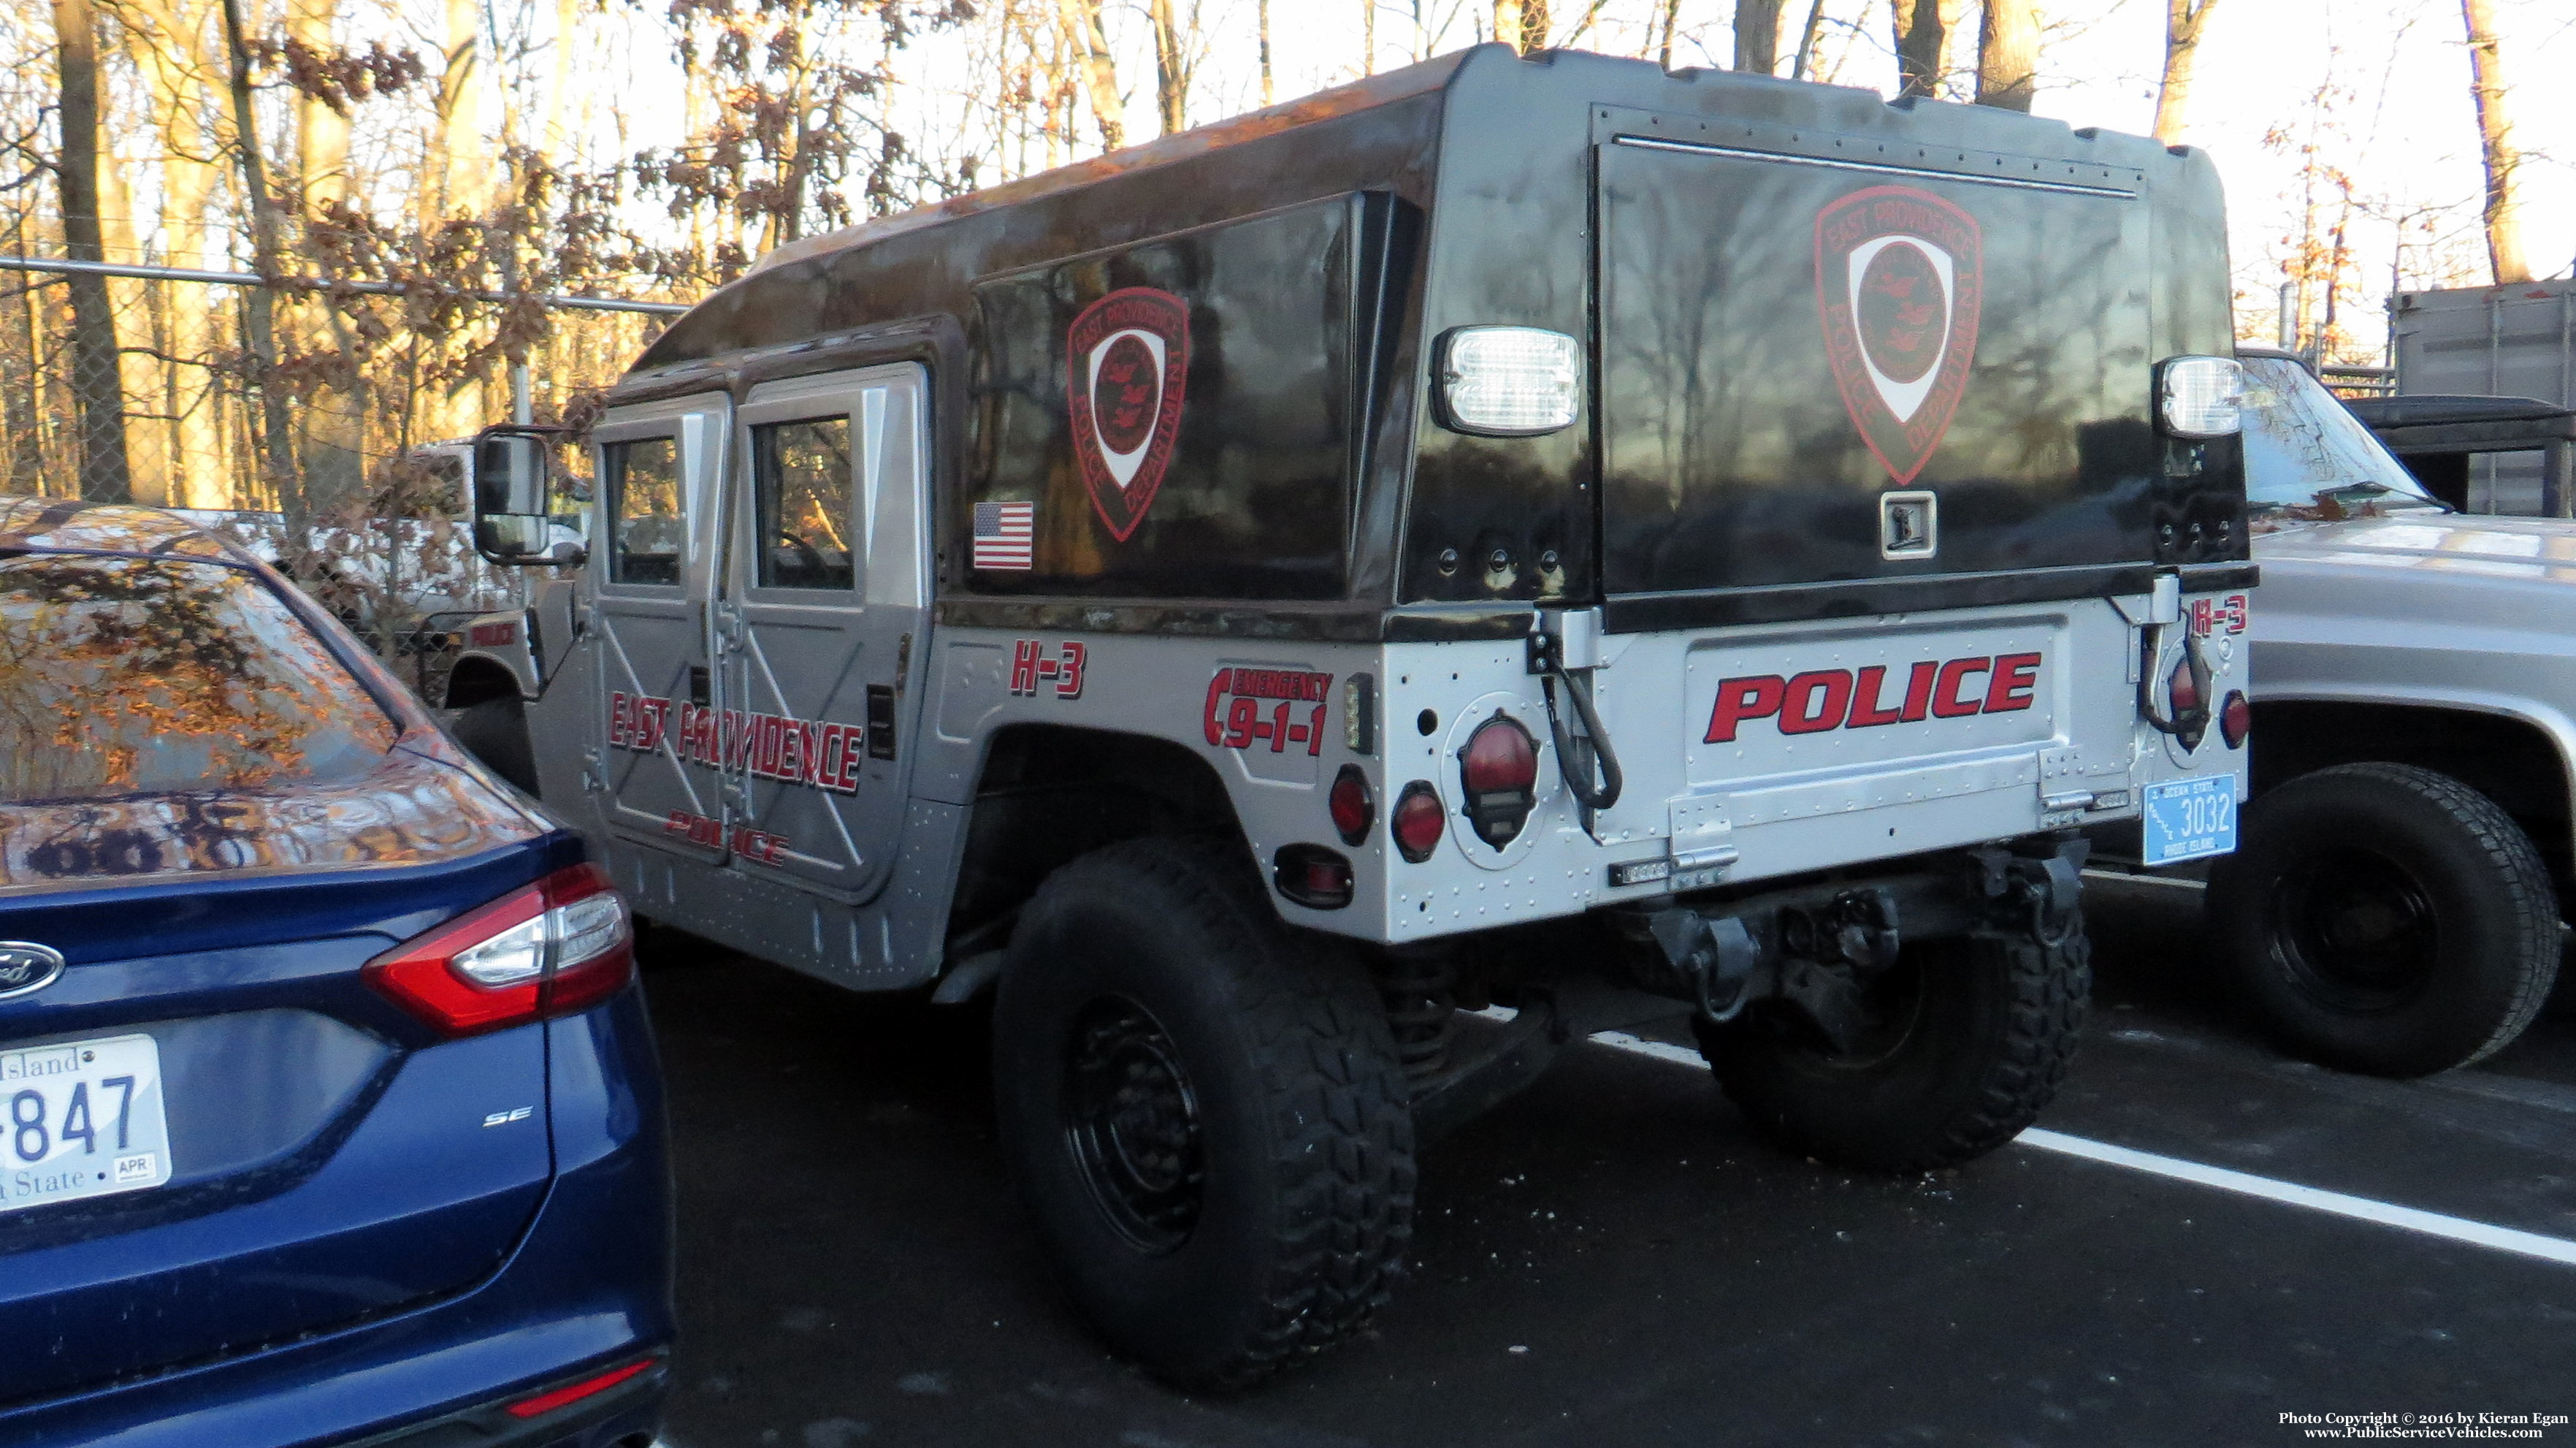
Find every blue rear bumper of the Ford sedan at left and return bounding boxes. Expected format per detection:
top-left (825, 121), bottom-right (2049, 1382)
top-left (0, 989), bottom-right (673, 1448)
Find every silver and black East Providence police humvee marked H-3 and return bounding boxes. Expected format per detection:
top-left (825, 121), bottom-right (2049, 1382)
top-left (479, 46), bottom-right (2254, 1386)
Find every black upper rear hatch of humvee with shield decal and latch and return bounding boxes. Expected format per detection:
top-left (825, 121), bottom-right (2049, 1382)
top-left (1594, 111), bottom-right (2161, 603)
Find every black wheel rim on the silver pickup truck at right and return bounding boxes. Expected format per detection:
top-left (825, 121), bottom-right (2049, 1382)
top-left (2272, 850), bottom-right (2442, 1013)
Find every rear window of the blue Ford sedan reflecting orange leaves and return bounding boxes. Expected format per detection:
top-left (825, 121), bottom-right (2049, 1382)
top-left (0, 554), bottom-right (400, 804)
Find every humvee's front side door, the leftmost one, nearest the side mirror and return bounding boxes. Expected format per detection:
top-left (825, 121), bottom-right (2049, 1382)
top-left (590, 395), bottom-right (732, 858)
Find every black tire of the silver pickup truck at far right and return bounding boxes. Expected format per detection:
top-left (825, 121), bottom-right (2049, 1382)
top-left (2208, 763), bottom-right (2558, 1077)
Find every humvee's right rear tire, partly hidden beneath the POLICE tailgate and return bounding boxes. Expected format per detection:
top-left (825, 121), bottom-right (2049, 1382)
top-left (1697, 923), bottom-right (2092, 1173)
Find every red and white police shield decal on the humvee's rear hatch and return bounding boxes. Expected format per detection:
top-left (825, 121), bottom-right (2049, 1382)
top-left (1816, 186), bottom-right (1986, 484)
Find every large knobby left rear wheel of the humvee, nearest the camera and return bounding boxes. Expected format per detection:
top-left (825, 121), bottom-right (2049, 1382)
top-left (992, 837), bottom-right (1414, 1389)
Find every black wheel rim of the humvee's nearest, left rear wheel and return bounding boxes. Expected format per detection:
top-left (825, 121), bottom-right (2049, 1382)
top-left (1064, 997), bottom-right (1203, 1252)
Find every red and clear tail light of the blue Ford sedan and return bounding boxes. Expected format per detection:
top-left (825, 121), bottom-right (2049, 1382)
top-left (366, 866), bottom-right (636, 1036)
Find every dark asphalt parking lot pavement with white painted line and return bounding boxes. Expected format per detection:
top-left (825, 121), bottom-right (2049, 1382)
top-left (646, 884), bottom-right (2576, 1448)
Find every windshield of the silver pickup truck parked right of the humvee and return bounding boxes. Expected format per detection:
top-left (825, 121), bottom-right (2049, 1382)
top-left (2241, 358), bottom-right (2442, 520)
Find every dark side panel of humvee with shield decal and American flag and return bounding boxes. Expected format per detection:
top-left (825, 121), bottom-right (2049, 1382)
top-left (958, 196), bottom-right (1365, 598)
